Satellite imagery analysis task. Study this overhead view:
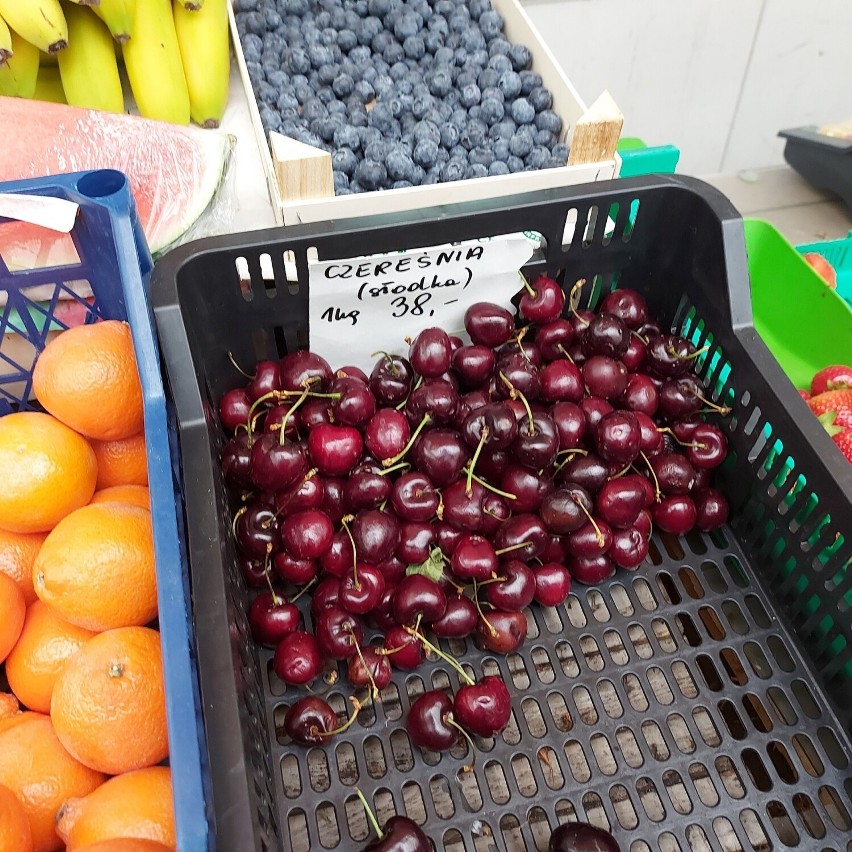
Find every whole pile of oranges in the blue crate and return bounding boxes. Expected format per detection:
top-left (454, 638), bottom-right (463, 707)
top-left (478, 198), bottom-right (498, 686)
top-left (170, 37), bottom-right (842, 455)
top-left (0, 321), bottom-right (176, 852)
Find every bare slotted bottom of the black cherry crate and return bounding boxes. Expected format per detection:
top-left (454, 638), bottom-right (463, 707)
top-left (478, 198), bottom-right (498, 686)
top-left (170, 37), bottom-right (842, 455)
top-left (248, 530), bottom-right (852, 852)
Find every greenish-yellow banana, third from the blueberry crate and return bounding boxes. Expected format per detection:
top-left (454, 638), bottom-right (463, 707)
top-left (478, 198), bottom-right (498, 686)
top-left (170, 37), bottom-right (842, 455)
top-left (59, 3), bottom-right (124, 113)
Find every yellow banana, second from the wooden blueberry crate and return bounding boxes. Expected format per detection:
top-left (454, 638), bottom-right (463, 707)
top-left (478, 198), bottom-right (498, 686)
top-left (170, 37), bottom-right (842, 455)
top-left (122, 0), bottom-right (189, 124)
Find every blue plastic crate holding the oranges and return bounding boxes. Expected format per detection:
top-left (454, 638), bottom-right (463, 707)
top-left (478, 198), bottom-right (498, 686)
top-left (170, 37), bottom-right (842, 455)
top-left (0, 170), bottom-right (209, 852)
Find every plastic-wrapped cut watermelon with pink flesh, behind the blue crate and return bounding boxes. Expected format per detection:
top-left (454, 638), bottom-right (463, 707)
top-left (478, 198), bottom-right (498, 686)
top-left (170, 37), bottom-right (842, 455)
top-left (0, 97), bottom-right (234, 269)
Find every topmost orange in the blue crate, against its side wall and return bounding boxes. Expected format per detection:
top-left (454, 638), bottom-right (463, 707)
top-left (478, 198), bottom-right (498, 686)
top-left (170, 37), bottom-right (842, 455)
top-left (33, 320), bottom-right (143, 441)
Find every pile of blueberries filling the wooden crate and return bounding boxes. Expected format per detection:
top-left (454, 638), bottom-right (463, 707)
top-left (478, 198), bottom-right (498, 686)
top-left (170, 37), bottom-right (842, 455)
top-left (234, 0), bottom-right (568, 195)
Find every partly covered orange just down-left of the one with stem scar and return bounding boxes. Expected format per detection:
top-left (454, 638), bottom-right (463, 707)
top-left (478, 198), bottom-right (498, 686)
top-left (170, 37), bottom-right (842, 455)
top-left (0, 713), bottom-right (106, 852)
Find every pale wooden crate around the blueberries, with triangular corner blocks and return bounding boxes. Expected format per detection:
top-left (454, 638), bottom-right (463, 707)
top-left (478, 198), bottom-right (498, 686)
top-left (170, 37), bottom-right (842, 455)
top-left (231, 0), bottom-right (623, 225)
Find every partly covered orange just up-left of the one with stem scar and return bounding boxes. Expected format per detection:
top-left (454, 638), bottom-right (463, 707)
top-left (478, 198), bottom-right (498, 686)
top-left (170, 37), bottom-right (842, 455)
top-left (6, 601), bottom-right (95, 713)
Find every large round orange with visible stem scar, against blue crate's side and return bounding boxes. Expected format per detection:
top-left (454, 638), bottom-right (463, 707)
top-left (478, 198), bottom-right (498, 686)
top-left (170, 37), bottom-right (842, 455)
top-left (50, 627), bottom-right (169, 775)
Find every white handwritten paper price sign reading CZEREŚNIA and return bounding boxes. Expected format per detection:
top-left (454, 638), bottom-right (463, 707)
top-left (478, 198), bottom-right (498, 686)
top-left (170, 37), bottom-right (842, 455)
top-left (309, 234), bottom-right (533, 373)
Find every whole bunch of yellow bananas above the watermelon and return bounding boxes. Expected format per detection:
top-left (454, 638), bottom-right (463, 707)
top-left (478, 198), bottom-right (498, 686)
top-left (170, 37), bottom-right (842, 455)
top-left (0, 0), bottom-right (230, 127)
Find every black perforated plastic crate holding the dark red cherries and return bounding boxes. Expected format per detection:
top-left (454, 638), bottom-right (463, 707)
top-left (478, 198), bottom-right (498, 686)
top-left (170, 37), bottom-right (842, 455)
top-left (153, 176), bottom-right (852, 852)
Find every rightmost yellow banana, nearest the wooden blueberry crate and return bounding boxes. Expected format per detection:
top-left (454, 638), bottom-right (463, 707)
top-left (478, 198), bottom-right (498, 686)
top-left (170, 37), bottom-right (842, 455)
top-left (174, 0), bottom-right (231, 127)
